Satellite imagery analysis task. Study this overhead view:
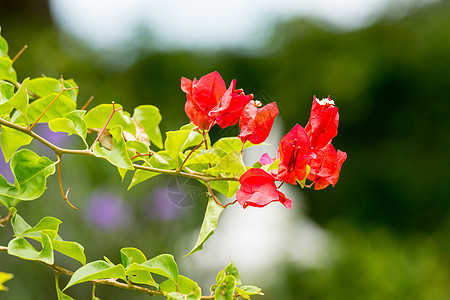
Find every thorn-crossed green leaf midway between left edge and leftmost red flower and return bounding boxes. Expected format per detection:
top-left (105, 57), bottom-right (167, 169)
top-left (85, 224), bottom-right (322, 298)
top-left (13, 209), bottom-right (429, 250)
top-left (84, 104), bottom-right (136, 136)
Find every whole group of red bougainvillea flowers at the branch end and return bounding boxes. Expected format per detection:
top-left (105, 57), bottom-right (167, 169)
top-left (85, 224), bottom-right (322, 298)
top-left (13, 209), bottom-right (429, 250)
top-left (181, 72), bottom-right (347, 208)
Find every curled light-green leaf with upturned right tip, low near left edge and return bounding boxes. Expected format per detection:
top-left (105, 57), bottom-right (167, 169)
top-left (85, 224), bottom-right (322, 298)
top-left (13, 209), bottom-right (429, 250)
top-left (8, 232), bottom-right (53, 265)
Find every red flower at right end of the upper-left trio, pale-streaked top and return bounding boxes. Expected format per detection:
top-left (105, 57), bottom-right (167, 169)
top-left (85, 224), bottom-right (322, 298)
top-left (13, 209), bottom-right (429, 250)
top-left (239, 101), bottom-right (278, 144)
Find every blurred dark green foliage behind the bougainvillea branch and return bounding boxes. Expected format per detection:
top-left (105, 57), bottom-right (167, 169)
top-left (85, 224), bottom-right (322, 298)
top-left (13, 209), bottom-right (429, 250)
top-left (0, 1), bottom-right (450, 299)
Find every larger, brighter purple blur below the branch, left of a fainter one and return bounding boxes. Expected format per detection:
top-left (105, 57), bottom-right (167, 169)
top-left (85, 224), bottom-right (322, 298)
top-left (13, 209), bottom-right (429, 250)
top-left (85, 192), bottom-right (131, 230)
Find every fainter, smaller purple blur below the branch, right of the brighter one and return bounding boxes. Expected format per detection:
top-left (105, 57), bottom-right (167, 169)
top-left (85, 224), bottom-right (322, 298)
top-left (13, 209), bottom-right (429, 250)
top-left (144, 187), bottom-right (181, 220)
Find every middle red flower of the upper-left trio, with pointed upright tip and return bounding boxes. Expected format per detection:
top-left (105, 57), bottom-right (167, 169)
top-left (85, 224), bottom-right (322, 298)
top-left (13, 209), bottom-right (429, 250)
top-left (208, 80), bottom-right (253, 128)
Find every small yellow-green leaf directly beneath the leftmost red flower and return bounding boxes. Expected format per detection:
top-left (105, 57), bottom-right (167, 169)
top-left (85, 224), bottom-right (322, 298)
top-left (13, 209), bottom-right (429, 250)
top-left (165, 129), bottom-right (203, 158)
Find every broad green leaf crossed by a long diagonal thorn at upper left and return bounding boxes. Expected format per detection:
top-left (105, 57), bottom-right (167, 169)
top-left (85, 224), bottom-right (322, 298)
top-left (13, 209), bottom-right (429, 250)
top-left (10, 93), bottom-right (77, 123)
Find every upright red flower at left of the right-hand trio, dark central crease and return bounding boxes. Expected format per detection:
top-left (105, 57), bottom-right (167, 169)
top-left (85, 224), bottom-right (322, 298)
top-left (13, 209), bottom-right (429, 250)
top-left (276, 124), bottom-right (315, 185)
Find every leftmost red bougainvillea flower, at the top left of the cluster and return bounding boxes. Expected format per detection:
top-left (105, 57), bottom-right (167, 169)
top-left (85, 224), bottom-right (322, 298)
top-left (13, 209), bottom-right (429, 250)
top-left (181, 72), bottom-right (227, 130)
